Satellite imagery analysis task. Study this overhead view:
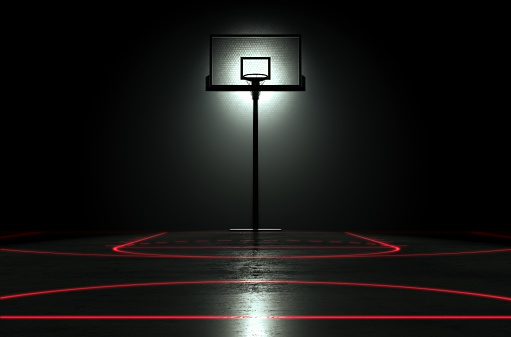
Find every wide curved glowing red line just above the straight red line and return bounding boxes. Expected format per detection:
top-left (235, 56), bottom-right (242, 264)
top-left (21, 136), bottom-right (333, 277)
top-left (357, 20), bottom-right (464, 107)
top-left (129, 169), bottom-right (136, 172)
top-left (0, 280), bottom-right (511, 302)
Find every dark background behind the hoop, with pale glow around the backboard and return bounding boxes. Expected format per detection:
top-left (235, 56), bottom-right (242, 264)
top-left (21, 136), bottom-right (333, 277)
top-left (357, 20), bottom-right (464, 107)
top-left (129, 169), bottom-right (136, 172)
top-left (7, 5), bottom-right (509, 231)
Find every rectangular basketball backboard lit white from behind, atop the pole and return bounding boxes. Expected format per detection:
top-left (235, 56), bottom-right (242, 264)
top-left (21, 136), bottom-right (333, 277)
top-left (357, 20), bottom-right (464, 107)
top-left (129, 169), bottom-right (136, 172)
top-left (206, 34), bottom-right (305, 91)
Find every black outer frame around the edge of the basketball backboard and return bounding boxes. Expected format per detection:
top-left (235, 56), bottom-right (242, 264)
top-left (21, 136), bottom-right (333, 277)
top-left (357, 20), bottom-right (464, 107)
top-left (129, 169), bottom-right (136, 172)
top-left (206, 34), bottom-right (305, 91)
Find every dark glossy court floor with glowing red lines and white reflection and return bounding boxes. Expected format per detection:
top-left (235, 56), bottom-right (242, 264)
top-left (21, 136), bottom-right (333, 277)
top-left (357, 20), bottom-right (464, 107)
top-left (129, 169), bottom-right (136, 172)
top-left (0, 231), bottom-right (511, 336)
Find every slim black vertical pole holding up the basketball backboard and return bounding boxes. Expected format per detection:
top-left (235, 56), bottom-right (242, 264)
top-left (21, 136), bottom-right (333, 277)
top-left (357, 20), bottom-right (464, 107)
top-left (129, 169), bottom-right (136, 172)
top-left (252, 90), bottom-right (259, 231)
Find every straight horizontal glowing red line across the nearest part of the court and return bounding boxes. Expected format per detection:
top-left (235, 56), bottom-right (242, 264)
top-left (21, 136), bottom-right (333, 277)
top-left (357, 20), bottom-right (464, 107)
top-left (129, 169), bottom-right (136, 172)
top-left (0, 315), bottom-right (511, 320)
